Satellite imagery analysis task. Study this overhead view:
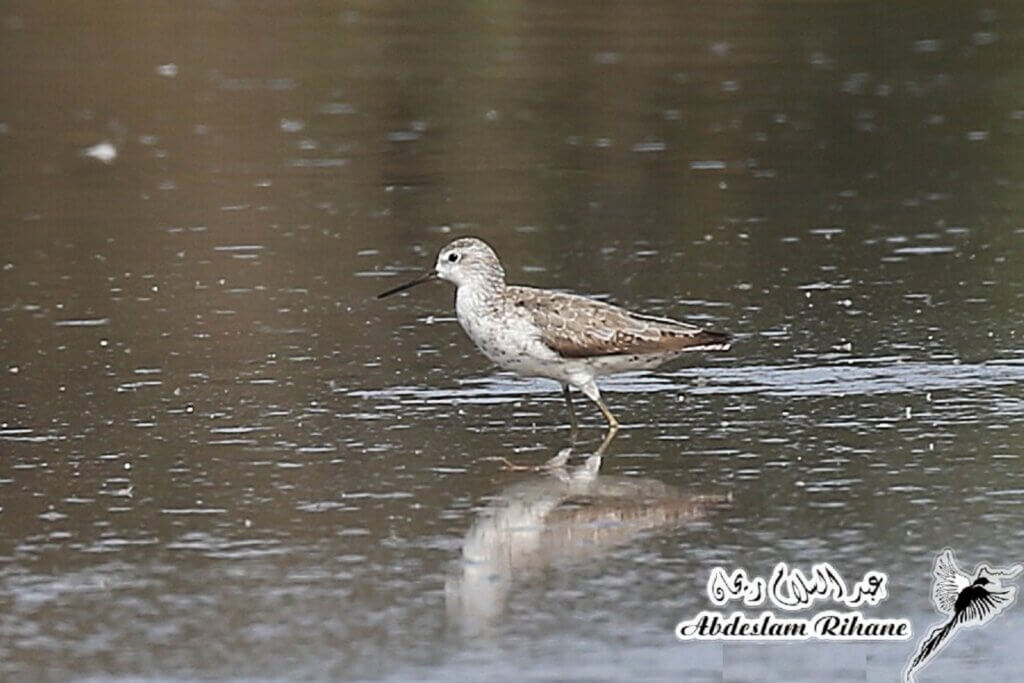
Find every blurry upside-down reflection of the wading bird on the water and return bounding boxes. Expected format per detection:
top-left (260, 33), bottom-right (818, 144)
top-left (445, 441), bottom-right (732, 635)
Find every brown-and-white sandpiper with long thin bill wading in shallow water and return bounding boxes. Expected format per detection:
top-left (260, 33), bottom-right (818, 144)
top-left (377, 238), bottom-right (729, 436)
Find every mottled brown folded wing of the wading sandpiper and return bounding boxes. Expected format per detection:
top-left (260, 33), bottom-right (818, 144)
top-left (509, 287), bottom-right (728, 358)
